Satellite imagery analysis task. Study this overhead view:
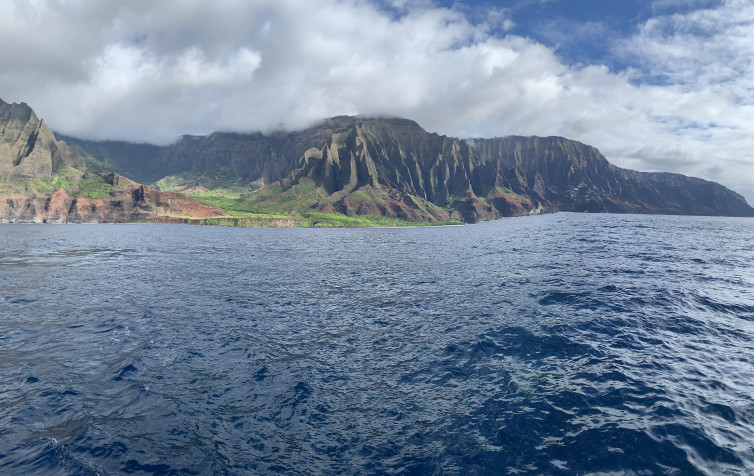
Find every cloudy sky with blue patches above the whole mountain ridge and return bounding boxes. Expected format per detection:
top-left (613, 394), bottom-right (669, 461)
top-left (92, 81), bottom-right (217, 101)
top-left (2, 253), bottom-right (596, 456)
top-left (0, 0), bottom-right (754, 204)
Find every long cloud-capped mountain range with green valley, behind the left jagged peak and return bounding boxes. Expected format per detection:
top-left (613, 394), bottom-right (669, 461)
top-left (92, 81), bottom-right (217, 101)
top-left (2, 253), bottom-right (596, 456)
top-left (60, 116), bottom-right (754, 223)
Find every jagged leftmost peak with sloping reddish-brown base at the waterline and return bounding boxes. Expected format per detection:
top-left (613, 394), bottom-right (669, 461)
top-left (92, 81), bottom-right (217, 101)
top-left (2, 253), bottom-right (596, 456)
top-left (0, 100), bottom-right (225, 223)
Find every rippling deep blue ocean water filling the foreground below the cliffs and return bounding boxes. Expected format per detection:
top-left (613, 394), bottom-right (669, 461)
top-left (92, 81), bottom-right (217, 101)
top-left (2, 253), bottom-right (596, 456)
top-left (0, 214), bottom-right (754, 475)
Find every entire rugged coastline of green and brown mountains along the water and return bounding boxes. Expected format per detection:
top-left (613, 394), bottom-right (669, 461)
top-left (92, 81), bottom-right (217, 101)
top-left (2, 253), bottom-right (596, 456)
top-left (5, 96), bottom-right (754, 226)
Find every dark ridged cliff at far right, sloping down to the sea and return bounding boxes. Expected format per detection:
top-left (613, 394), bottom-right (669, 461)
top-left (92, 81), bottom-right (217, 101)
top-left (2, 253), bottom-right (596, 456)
top-left (471, 137), bottom-right (754, 216)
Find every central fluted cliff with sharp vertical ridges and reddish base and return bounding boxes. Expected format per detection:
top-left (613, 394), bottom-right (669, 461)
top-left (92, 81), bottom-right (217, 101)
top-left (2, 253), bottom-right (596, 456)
top-left (280, 117), bottom-right (550, 223)
